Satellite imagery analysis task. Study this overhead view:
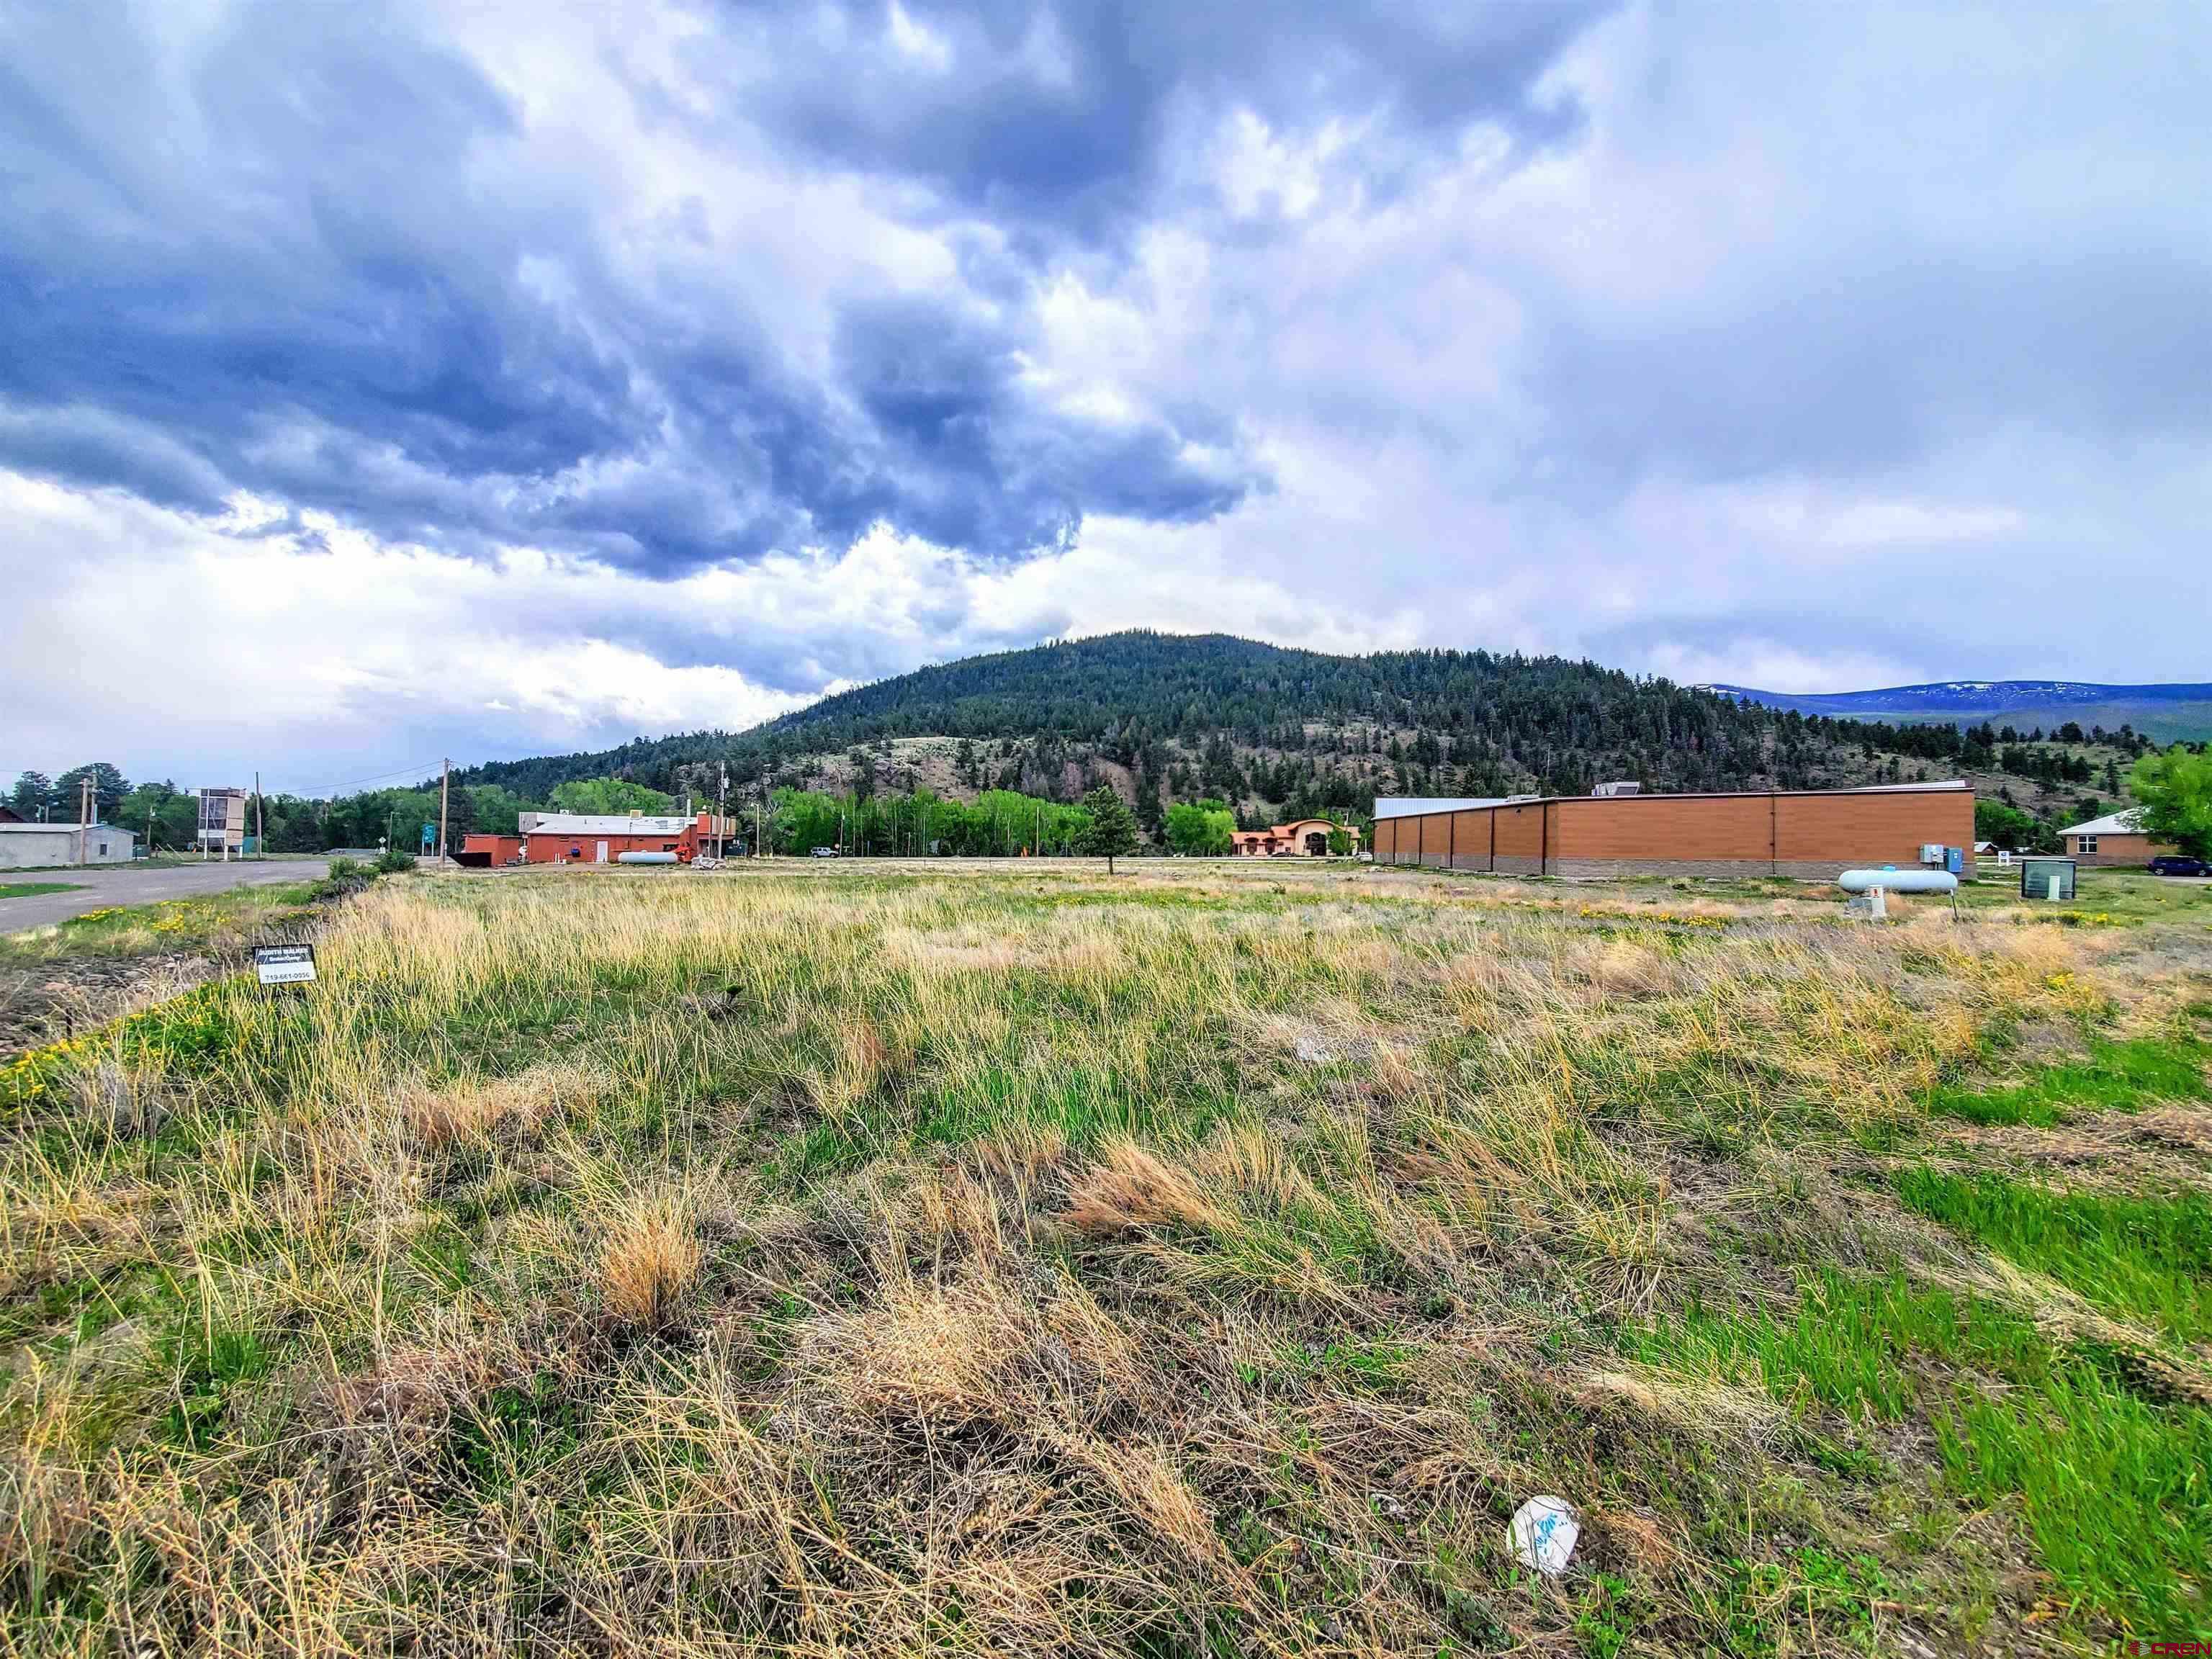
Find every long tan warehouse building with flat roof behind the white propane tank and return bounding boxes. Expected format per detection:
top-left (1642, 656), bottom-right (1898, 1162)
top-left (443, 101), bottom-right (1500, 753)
top-left (1374, 783), bottom-right (1973, 881)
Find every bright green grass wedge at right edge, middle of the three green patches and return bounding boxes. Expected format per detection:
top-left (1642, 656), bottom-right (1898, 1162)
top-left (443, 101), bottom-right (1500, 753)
top-left (1896, 1168), bottom-right (2212, 1343)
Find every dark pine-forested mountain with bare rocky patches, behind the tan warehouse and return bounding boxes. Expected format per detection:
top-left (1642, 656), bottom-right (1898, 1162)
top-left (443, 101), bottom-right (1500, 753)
top-left (460, 633), bottom-right (2008, 823)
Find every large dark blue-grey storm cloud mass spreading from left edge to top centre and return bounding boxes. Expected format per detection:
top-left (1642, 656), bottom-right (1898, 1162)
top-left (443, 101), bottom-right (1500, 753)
top-left (0, 4), bottom-right (1588, 575)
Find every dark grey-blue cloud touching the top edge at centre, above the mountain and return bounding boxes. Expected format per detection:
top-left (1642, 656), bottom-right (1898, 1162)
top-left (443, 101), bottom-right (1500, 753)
top-left (706, 0), bottom-right (1610, 239)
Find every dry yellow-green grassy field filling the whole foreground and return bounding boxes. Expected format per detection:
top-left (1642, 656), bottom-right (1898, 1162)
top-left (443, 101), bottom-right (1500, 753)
top-left (0, 863), bottom-right (2212, 1659)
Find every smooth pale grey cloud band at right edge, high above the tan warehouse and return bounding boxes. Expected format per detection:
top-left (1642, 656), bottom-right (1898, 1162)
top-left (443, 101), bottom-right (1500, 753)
top-left (1535, 248), bottom-right (2212, 500)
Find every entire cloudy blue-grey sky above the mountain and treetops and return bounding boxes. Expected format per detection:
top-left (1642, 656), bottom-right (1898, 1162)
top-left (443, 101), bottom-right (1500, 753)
top-left (0, 0), bottom-right (2212, 792)
